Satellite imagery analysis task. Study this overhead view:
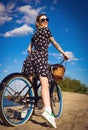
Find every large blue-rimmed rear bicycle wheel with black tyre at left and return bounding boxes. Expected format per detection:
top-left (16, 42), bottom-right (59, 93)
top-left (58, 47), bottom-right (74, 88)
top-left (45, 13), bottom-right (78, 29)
top-left (0, 74), bottom-right (34, 126)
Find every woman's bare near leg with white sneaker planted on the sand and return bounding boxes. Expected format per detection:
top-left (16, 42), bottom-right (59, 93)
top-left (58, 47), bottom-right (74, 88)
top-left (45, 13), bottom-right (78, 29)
top-left (40, 76), bottom-right (57, 128)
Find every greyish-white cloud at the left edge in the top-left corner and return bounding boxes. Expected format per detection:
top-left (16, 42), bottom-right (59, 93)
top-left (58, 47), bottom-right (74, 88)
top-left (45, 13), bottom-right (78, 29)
top-left (0, 3), bottom-right (15, 25)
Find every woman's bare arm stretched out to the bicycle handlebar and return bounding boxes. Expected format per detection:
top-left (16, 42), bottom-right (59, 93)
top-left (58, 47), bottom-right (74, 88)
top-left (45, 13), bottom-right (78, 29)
top-left (50, 37), bottom-right (68, 60)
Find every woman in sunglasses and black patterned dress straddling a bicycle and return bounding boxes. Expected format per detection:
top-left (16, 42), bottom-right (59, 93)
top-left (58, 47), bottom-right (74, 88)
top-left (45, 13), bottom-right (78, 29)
top-left (22, 14), bottom-right (68, 128)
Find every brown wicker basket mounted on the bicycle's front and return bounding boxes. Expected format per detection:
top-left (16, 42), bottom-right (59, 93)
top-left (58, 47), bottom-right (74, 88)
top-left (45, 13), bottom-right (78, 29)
top-left (53, 65), bottom-right (65, 81)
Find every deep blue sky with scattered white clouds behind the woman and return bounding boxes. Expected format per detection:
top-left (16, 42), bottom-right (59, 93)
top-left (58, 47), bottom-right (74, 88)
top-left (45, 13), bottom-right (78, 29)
top-left (0, 0), bottom-right (88, 86)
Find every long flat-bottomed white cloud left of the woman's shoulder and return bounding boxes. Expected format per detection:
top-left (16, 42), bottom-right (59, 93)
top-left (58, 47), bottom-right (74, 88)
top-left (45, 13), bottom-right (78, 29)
top-left (1, 25), bottom-right (33, 37)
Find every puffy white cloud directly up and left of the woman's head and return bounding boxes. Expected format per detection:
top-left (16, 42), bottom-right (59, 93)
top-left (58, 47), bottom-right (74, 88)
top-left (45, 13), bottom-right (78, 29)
top-left (17, 5), bottom-right (44, 24)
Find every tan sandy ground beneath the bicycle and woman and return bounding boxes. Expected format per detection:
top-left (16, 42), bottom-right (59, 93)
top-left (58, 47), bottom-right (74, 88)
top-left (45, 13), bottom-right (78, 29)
top-left (0, 92), bottom-right (88, 130)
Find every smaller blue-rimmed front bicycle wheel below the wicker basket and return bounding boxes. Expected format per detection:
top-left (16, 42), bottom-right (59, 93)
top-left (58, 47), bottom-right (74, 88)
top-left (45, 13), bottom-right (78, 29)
top-left (50, 82), bottom-right (63, 118)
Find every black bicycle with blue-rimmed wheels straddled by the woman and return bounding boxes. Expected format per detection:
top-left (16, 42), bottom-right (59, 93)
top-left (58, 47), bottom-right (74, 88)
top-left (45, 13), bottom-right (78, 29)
top-left (0, 60), bottom-right (64, 126)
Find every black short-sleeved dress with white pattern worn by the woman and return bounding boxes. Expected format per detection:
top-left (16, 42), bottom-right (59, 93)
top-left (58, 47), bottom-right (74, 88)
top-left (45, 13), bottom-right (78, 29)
top-left (22, 28), bottom-right (52, 82)
